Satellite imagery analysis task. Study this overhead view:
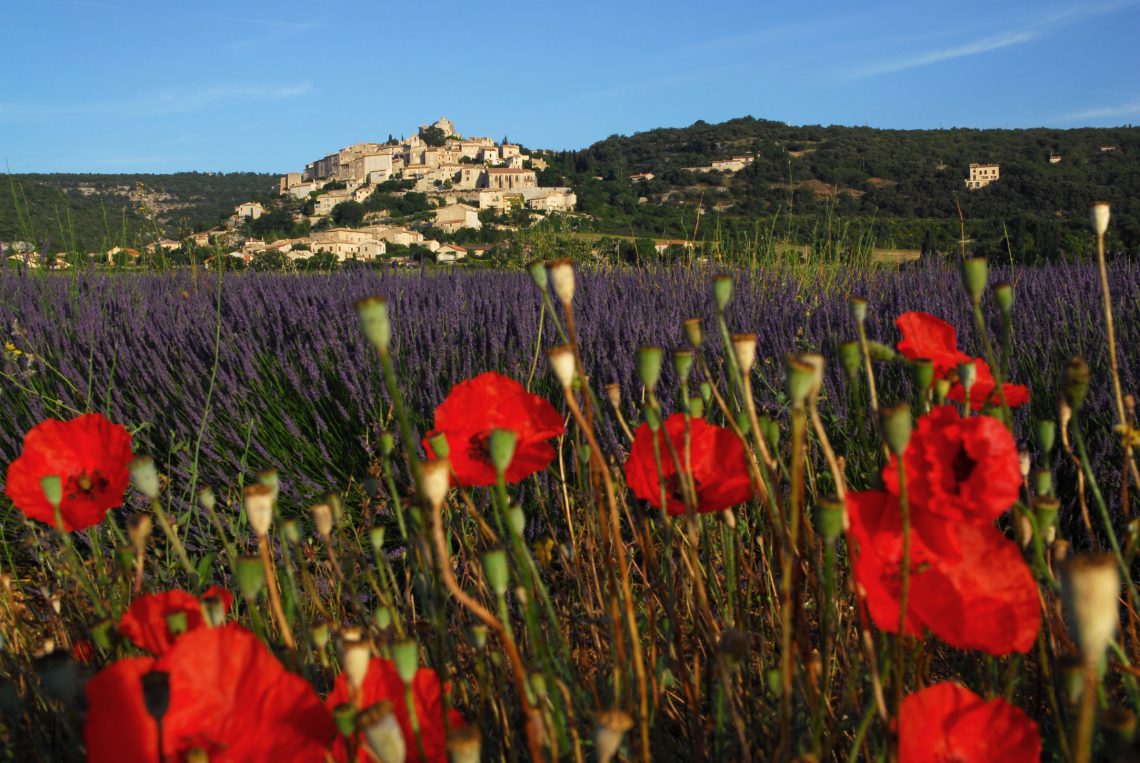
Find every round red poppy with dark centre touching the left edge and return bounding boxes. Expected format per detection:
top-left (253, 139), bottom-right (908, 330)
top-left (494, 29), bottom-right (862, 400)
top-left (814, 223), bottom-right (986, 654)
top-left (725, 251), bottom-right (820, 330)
top-left (5, 413), bottom-right (135, 531)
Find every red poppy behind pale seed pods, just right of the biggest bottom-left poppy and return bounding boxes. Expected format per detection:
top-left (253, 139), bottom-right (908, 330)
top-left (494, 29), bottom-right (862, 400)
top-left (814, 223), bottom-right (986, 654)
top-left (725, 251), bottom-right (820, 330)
top-left (325, 657), bottom-right (466, 763)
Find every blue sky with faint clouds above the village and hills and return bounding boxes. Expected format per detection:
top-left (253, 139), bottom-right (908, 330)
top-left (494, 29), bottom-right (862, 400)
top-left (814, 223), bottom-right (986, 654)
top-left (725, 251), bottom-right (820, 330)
top-left (0, 0), bottom-right (1140, 172)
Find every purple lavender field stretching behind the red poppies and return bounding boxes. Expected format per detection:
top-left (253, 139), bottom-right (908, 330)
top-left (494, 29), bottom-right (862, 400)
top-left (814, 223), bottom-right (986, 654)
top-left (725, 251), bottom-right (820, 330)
top-left (0, 263), bottom-right (1140, 517)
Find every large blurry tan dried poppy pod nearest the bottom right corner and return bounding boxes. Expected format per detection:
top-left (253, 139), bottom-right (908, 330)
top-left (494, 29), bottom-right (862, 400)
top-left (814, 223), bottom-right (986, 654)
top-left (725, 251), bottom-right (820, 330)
top-left (1061, 554), bottom-right (1121, 665)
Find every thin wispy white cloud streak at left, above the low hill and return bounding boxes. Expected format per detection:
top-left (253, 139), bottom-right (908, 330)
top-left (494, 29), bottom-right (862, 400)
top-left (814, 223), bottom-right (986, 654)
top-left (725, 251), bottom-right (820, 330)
top-left (0, 82), bottom-right (312, 122)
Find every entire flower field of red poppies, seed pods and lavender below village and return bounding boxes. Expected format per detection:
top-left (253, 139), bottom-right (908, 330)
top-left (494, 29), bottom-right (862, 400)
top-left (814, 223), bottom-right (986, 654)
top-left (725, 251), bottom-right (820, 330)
top-left (0, 206), bottom-right (1140, 762)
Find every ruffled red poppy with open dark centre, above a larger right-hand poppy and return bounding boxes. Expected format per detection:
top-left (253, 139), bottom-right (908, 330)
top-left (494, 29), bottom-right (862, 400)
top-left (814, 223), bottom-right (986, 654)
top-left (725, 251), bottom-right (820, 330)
top-left (882, 405), bottom-right (1021, 555)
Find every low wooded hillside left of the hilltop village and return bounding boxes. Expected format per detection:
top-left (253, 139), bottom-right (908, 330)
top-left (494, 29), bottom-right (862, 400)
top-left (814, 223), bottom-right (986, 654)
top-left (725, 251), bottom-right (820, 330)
top-left (0, 172), bottom-right (277, 251)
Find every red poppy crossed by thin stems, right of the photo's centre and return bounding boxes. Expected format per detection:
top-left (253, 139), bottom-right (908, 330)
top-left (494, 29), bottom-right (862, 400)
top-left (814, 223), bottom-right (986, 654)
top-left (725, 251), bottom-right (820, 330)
top-left (626, 413), bottom-right (752, 516)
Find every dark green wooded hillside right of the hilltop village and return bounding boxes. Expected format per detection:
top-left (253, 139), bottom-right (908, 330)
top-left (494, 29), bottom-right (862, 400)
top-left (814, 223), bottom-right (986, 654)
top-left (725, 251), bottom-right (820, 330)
top-left (533, 116), bottom-right (1140, 259)
